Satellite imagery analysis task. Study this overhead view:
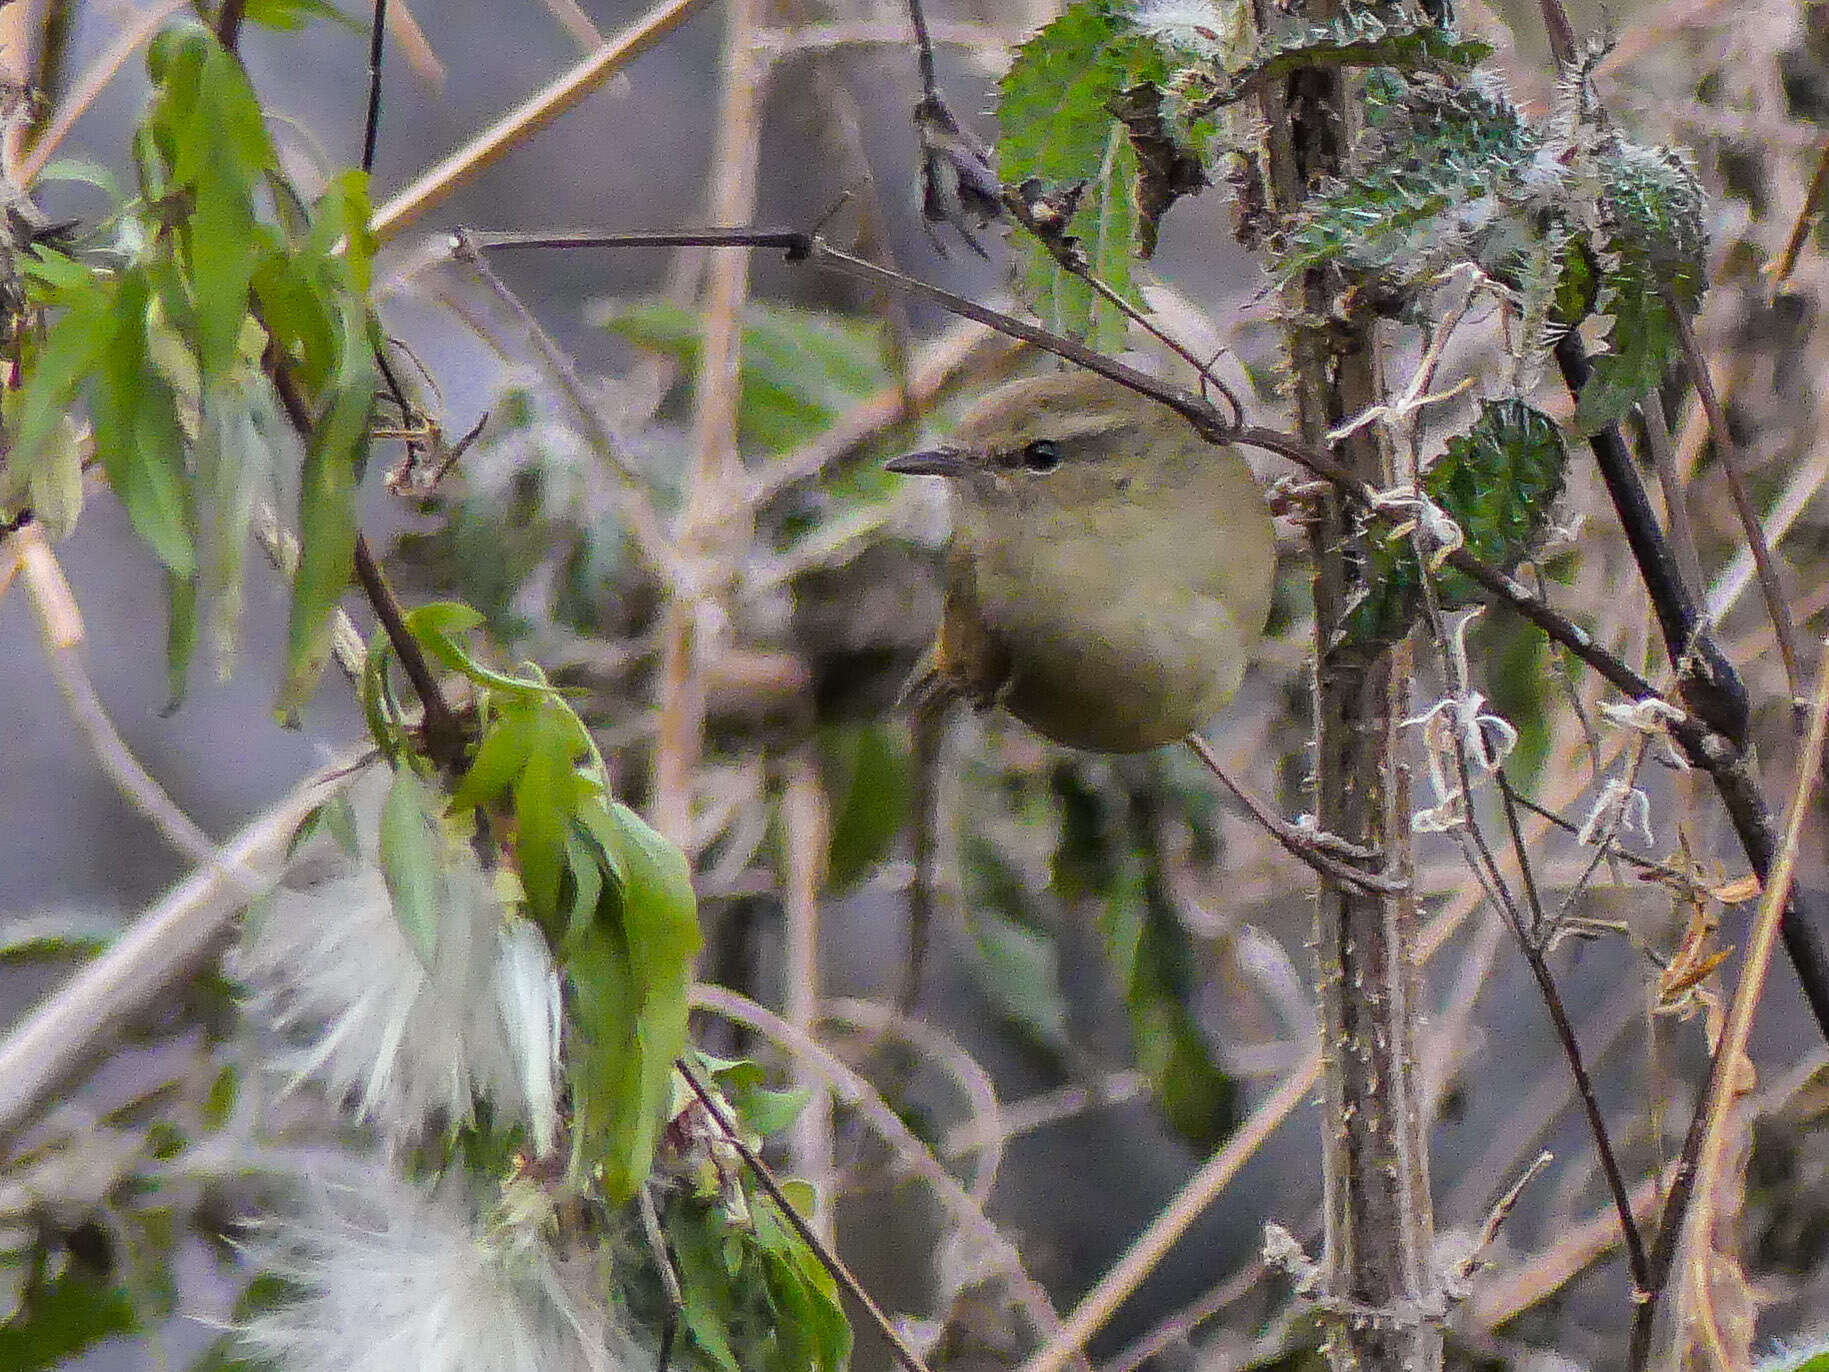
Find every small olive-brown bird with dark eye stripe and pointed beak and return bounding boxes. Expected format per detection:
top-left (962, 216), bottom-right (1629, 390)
top-left (891, 371), bottom-right (1275, 752)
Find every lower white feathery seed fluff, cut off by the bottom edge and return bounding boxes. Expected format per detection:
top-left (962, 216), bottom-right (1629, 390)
top-left (236, 1169), bottom-right (632, 1372)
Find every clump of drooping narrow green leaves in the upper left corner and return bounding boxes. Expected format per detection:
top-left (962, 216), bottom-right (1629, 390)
top-left (0, 24), bottom-right (379, 713)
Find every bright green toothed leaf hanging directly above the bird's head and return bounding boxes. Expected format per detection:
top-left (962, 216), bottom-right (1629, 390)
top-left (997, 0), bottom-right (1172, 353)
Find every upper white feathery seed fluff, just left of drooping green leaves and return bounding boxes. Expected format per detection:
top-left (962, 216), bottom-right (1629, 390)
top-left (229, 766), bottom-right (560, 1154)
